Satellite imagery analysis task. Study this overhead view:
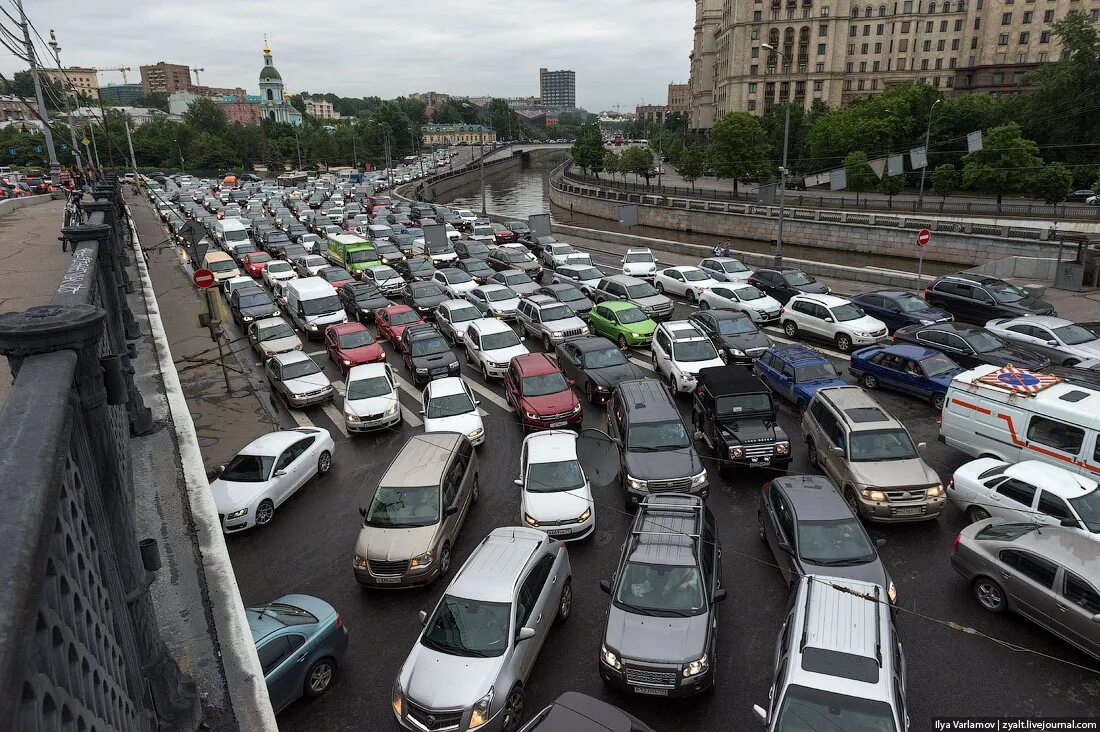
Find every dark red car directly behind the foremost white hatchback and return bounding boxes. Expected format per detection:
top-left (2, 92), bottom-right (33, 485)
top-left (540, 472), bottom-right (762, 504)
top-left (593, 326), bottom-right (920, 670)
top-left (504, 353), bottom-right (584, 431)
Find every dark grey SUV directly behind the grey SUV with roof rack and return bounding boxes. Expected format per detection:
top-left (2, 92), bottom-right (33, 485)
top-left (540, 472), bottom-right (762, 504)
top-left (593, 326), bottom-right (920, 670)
top-left (607, 379), bottom-right (710, 509)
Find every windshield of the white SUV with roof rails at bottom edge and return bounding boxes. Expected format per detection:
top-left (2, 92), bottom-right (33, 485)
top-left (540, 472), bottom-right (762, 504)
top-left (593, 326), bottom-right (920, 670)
top-left (773, 684), bottom-right (898, 732)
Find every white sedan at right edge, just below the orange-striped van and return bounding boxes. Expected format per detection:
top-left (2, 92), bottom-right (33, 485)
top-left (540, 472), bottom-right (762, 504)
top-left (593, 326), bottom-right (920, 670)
top-left (947, 458), bottom-right (1100, 540)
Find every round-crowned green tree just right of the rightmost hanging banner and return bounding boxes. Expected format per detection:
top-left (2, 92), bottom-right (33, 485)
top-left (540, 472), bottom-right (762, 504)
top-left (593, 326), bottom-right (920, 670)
top-left (963, 122), bottom-right (1043, 203)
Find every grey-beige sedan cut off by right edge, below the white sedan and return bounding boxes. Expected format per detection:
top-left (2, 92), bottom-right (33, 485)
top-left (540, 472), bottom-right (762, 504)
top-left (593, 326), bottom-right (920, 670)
top-left (952, 518), bottom-right (1100, 658)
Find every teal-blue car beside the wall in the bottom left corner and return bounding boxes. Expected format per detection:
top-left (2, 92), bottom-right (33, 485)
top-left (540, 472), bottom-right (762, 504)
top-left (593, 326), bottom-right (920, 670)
top-left (244, 594), bottom-right (348, 713)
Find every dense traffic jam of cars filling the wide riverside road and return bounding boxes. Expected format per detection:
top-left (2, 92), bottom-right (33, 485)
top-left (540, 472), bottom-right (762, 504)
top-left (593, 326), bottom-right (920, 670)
top-left (149, 159), bottom-right (1100, 732)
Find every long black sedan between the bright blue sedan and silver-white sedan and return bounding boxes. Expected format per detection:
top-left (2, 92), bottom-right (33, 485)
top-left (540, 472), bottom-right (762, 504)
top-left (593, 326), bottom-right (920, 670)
top-left (893, 323), bottom-right (1051, 371)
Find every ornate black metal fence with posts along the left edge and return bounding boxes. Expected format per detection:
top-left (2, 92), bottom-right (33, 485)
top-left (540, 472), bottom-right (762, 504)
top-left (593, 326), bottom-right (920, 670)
top-left (0, 178), bottom-right (201, 731)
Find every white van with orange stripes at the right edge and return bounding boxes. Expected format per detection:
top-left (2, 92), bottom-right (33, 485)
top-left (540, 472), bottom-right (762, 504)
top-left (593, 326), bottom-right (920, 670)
top-left (939, 365), bottom-right (1100, 478)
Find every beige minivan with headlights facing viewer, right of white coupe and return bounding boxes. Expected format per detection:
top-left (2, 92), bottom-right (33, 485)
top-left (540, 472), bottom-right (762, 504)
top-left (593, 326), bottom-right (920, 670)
top-left (353, 433), bottom-right (480, 587)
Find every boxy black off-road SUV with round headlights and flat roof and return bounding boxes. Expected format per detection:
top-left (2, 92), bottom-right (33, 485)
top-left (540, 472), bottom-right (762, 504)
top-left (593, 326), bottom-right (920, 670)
top-left (691, 365), bottom-right (791, 476)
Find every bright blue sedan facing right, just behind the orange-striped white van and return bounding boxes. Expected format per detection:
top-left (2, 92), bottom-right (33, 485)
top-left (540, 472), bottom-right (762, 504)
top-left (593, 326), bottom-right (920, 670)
top-left (848, 343), bottom-right (963, 412)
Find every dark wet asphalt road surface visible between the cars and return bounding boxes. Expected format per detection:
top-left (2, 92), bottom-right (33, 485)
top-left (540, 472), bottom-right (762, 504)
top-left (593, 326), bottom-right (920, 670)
top-left (148, 210), bottom-right (1100, 732)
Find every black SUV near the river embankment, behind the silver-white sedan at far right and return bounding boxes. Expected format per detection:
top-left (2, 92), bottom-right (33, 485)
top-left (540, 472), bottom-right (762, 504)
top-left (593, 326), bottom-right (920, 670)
top-left (924, 274), bottom-right (1057, 326)
